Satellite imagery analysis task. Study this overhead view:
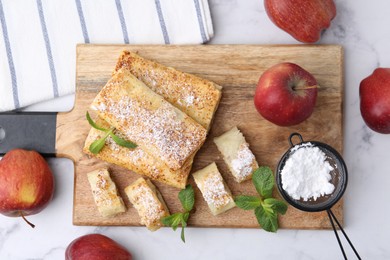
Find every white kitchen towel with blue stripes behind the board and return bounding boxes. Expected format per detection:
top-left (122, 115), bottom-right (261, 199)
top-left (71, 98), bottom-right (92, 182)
top-left (0, 0), bottom-right (213, 111)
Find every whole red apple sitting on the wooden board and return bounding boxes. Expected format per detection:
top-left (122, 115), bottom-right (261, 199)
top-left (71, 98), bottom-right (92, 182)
top-left (254, 62), bottom-right (318, 126)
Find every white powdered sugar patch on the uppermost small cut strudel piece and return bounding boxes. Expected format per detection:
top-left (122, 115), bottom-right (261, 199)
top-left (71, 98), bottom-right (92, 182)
top-left (232, 143), bottom-right (255, 182)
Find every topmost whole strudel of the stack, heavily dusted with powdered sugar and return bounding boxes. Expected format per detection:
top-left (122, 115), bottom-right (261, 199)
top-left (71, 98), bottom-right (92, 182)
top-left (96, 78), bottom-right (206, 169)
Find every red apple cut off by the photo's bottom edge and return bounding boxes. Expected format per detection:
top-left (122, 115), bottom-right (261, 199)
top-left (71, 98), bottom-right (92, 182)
top-left (65, 234), bottom-right (132, 260)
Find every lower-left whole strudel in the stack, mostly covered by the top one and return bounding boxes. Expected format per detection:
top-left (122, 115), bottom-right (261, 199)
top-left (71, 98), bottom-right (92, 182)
top-left (83, 117), bottom-right (193, 189)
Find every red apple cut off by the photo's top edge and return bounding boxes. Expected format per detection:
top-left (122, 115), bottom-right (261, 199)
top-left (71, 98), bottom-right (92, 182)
top-left (264, 0), bottom-right (336, 43)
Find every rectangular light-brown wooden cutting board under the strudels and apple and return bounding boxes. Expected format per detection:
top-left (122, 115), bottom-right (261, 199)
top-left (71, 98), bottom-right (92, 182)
top-left (56, 44), bottom-right (343, 229)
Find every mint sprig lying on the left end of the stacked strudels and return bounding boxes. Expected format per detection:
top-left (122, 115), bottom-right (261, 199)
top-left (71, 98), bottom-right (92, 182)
top-left (86, 111), bottom-right (137, 154)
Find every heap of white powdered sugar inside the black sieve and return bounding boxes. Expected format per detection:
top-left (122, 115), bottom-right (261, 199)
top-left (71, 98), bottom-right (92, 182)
top-left (281, 143), bottom-right (335, 201)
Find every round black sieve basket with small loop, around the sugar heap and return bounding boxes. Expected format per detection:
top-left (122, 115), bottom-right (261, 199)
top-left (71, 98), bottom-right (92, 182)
top-left (276, 133), bottom-right (348, 212)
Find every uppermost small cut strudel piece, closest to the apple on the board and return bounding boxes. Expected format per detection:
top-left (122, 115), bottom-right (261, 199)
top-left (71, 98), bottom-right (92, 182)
top-left (214, 127), bottom-right (259, 183)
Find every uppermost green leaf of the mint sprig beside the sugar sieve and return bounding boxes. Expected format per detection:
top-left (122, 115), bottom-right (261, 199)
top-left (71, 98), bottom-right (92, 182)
top-left (252, 166), bottom-right (275, 199)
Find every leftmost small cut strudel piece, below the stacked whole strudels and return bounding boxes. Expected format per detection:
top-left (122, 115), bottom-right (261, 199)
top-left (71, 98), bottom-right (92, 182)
top-left (87, 168), bottom-right (126, 217)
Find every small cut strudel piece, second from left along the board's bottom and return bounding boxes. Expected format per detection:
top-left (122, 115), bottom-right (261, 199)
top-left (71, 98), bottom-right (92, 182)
top-left (125, 178), bottom-right (169, 231)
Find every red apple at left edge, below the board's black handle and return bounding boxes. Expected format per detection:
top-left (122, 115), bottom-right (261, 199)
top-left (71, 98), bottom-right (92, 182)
top-left (0, 149), bottom-right (54, 227)
